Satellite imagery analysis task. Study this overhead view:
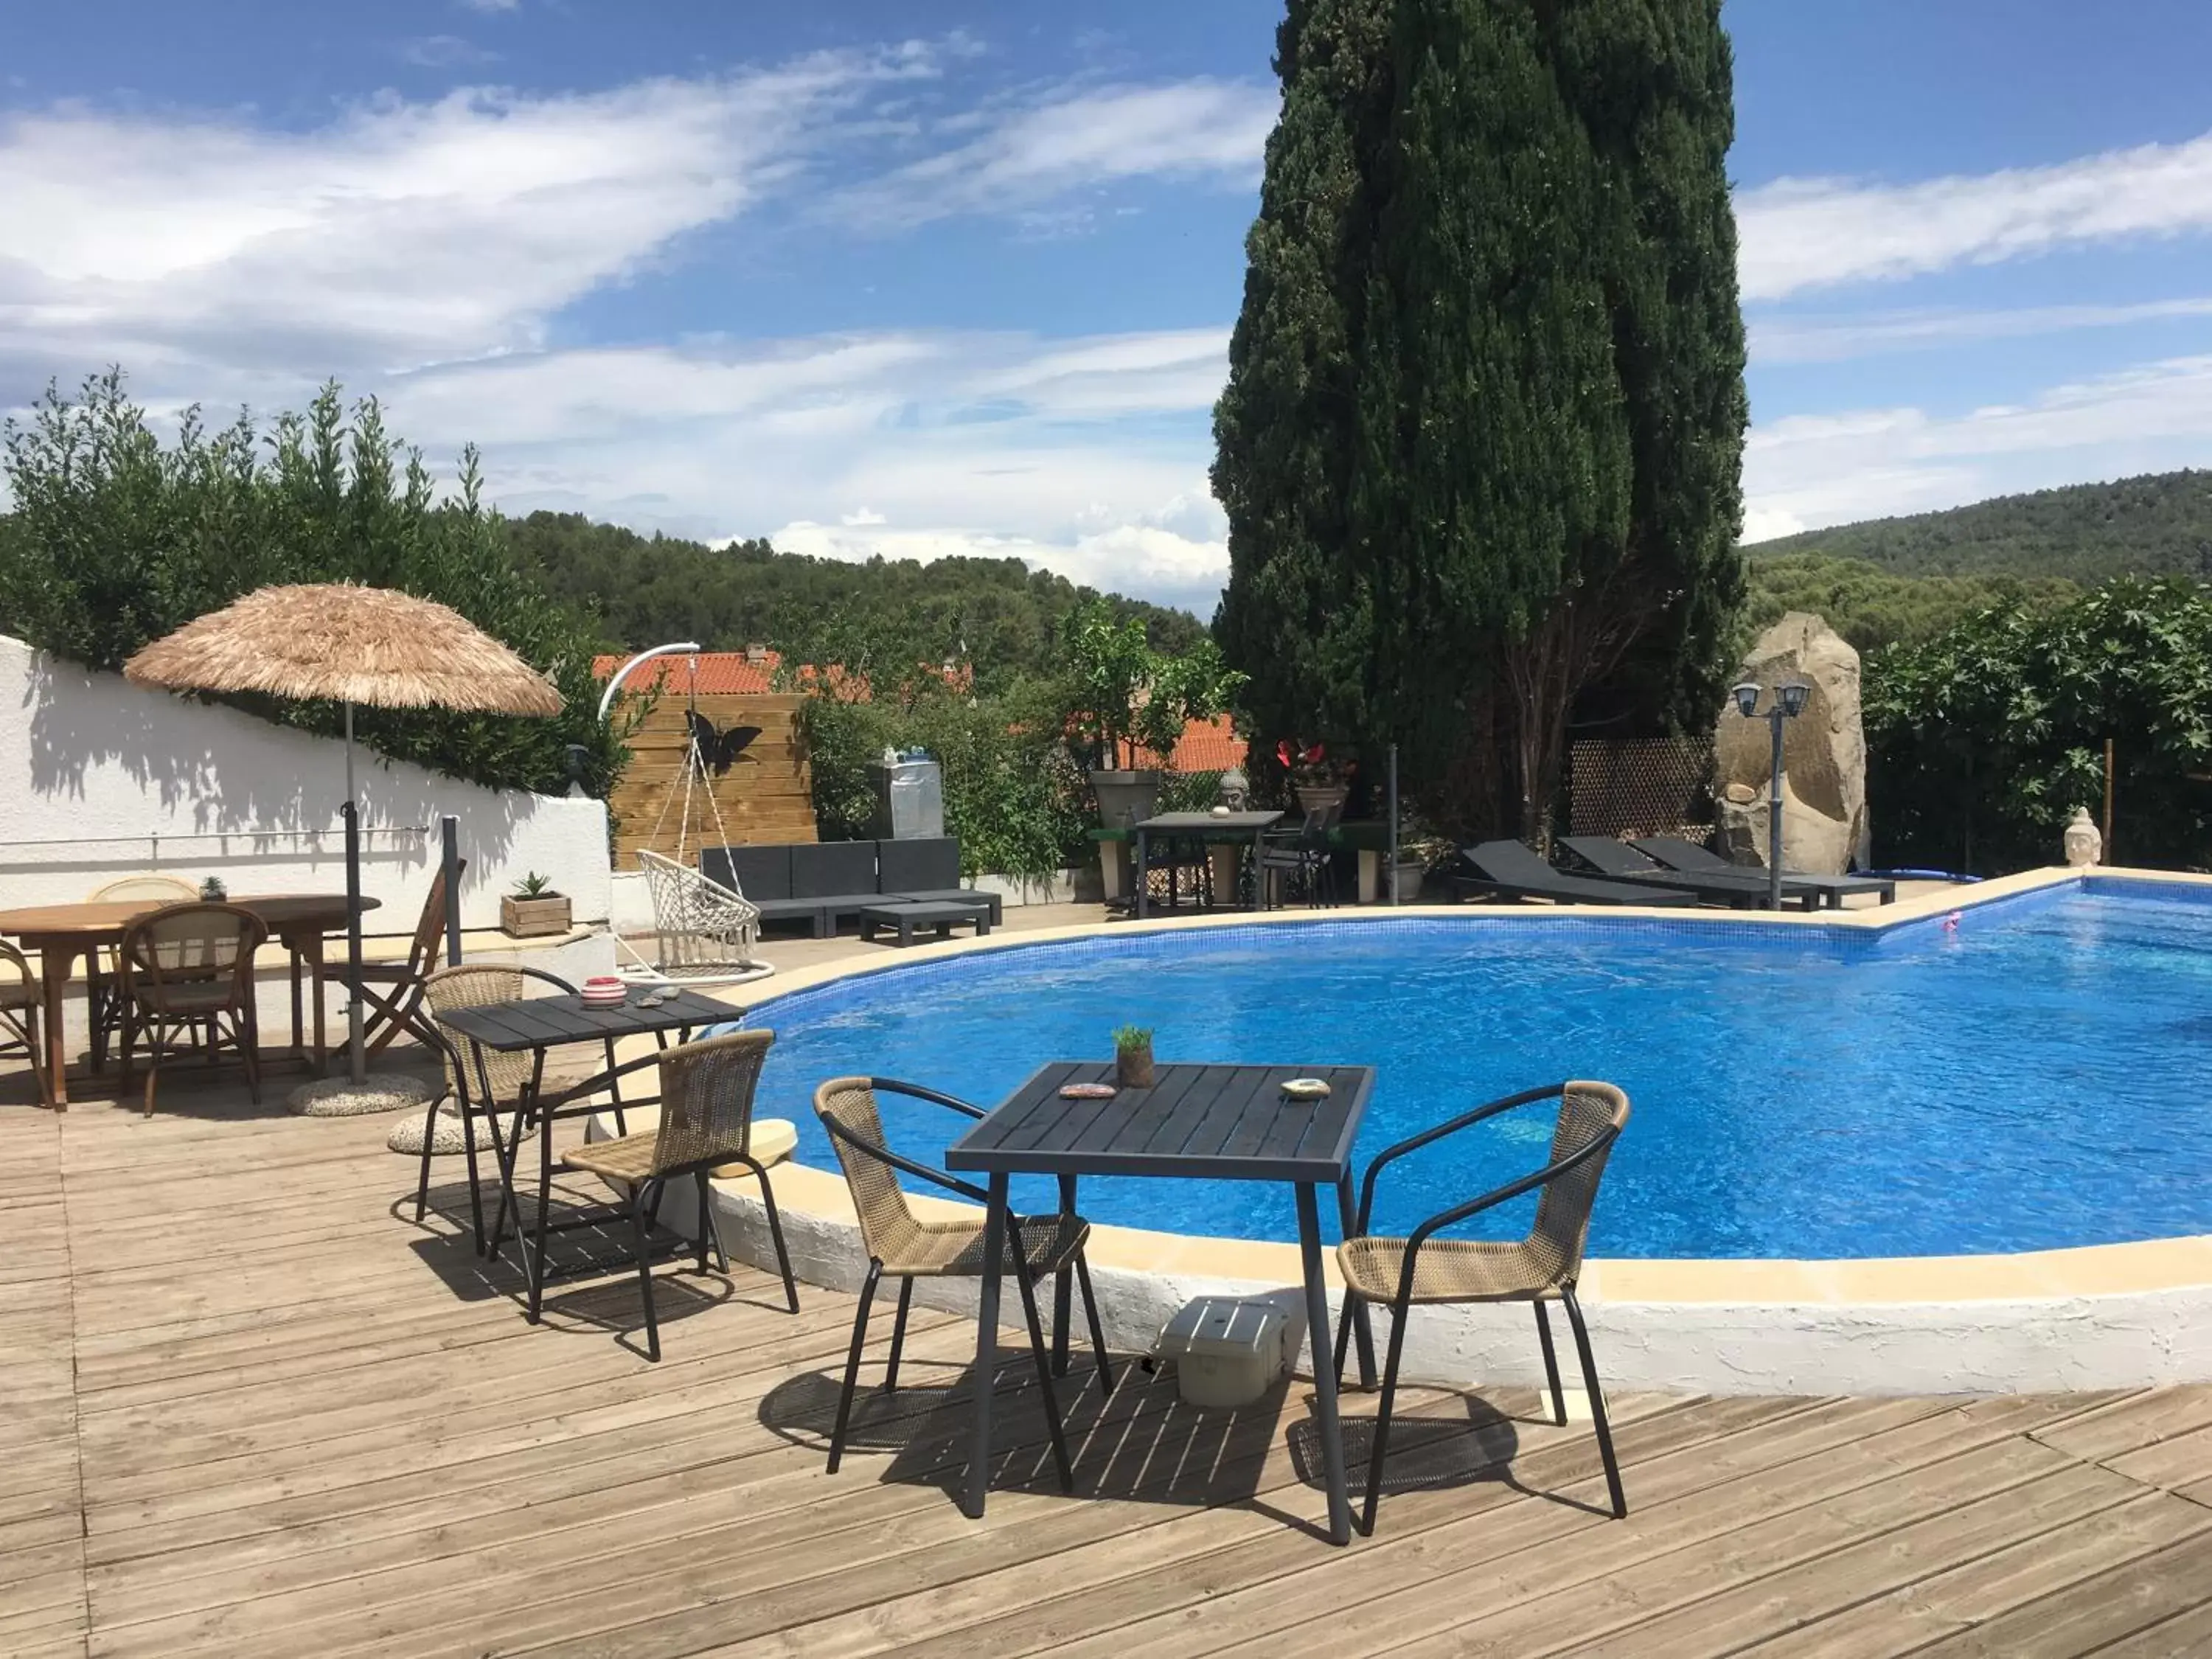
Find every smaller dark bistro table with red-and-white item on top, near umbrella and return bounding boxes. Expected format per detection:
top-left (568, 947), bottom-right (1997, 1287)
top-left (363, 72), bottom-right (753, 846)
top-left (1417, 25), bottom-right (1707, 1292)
top-left (438, 995), bottom-right (745, 1325)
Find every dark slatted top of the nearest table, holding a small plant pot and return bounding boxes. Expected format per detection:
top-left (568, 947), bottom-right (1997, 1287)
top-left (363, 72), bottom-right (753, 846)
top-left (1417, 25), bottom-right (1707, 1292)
top-left (945, 1060), bottom-right (1374, 1183)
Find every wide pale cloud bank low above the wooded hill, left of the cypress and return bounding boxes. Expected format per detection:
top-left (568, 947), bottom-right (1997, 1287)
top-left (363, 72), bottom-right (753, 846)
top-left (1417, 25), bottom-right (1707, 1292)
top-left (363, 330), bottom-right (1228, 613)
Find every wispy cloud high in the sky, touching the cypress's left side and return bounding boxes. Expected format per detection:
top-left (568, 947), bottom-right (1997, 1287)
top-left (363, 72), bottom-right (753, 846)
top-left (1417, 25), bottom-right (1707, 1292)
top-left (827, 80), bottom-right (1276, 230)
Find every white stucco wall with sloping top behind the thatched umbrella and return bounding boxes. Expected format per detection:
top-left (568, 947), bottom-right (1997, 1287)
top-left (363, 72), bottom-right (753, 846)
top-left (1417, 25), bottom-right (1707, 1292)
top-left (0, 635), bottom-right (611, 933)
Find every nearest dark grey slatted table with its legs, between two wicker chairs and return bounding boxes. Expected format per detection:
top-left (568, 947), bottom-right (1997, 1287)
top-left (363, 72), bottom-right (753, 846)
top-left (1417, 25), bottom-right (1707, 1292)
top-left (945, 1060), bottom-right (1376, 1544)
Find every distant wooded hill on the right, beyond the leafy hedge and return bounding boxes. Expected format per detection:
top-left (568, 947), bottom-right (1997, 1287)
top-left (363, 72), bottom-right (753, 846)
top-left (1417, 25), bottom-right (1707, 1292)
top-left (1745, 469), bottom-right (2212, 586)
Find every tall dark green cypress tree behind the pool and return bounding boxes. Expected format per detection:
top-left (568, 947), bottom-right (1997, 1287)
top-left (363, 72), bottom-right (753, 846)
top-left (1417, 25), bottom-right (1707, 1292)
top-left (1214, 0), bottom-right (1743, 834)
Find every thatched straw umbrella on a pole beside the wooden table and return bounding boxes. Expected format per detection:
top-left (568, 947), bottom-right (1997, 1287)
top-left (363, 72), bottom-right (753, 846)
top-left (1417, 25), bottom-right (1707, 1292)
top-left (124, 582), bottom-right (562, 1084)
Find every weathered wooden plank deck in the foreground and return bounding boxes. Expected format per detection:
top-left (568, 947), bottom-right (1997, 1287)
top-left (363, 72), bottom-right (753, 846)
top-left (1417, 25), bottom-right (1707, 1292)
top-left (0, 1077), bottom-right (2212, 1659)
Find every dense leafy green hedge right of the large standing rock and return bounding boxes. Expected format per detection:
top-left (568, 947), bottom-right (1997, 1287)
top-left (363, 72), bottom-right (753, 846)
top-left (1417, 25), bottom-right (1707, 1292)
top-left (1865, 577), bottom-right (2212, 874)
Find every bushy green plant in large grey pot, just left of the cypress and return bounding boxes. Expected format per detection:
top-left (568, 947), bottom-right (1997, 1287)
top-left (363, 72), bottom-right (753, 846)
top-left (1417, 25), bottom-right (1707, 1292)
top-left (1060, 599), bottom-right (1243, 830)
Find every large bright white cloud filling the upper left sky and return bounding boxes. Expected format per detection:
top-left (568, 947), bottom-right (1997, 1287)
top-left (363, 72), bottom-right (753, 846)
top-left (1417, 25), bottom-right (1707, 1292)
top-left (0, 46), bottom-right (931, 389)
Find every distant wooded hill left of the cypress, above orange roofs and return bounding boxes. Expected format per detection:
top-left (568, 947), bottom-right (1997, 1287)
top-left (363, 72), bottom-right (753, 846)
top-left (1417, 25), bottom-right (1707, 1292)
top-left (507, 513), bottom-right (1206, 688)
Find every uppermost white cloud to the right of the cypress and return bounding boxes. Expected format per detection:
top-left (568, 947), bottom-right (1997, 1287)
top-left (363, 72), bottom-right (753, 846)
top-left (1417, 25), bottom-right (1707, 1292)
top-left (1736, 133), bottom-right (2212, 301)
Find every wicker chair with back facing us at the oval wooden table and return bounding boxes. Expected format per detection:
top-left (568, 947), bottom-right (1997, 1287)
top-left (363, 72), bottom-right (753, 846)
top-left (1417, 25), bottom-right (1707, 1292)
top-left (119, 902), bottom-right (268, 1117)
